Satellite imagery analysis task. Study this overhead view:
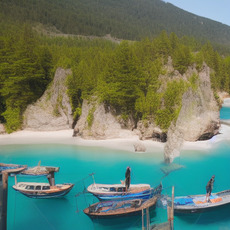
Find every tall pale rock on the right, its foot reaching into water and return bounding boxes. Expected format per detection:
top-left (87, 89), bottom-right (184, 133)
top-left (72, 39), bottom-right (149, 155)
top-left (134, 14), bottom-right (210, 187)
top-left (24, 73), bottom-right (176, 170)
top-left (165, 64), bottom-right (220, 162)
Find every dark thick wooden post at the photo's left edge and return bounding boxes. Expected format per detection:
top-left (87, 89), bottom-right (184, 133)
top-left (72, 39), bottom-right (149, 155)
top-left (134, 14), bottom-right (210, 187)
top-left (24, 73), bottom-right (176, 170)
top-left (0, 171), bottom-right (8, 230)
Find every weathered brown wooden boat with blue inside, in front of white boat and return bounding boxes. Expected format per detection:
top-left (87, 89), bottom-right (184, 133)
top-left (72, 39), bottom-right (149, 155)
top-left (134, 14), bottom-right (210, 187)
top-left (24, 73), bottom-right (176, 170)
top-left (84, 196), bottom-right (157, 218)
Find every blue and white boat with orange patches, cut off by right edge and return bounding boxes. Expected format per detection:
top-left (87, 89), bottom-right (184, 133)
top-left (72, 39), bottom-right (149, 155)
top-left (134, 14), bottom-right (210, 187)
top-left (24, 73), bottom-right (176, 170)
top-left (174, 190), bottom-right (230, 213)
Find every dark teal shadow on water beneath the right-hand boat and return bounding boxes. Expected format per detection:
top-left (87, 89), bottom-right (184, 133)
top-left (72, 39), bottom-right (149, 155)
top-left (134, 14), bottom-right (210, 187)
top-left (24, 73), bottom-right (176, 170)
top-left (175, 204), bottom-right (230, 225)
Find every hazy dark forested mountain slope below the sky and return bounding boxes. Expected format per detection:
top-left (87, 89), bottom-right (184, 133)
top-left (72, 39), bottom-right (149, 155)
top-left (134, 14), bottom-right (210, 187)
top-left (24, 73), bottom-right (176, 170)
top-left (0, 0), bottom-right (230, 46)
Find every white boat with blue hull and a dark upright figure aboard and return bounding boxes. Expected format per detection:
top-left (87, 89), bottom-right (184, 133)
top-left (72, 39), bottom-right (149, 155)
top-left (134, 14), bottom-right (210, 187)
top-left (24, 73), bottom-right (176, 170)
top-left (87, 183), bottom-right (162, 200)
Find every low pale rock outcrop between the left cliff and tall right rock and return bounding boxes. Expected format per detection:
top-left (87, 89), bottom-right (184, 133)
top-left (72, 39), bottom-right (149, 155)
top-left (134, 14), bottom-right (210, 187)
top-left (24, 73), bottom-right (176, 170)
top-left (73, 98), bottom-right (164, 142)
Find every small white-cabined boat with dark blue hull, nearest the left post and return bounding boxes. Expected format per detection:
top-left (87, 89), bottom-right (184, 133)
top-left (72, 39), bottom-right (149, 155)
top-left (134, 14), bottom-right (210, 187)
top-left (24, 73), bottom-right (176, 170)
top-left (13, 182), bottom-right (74, 198)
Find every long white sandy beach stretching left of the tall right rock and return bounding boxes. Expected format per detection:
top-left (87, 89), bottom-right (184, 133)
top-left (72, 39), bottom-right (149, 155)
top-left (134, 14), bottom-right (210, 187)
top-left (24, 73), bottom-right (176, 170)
top-left (0, 129), bottom-right (164, 152)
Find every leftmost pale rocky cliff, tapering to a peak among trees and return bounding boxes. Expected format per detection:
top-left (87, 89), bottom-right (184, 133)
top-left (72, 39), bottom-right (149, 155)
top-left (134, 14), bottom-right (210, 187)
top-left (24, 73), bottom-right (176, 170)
top-left (23, 68), bottom-right (73, 131)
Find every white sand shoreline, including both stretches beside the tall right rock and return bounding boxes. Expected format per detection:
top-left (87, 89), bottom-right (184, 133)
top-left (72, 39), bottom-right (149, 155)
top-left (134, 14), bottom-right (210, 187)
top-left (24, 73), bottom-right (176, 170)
top-left (0, 124), bottom-right (230, 154)
